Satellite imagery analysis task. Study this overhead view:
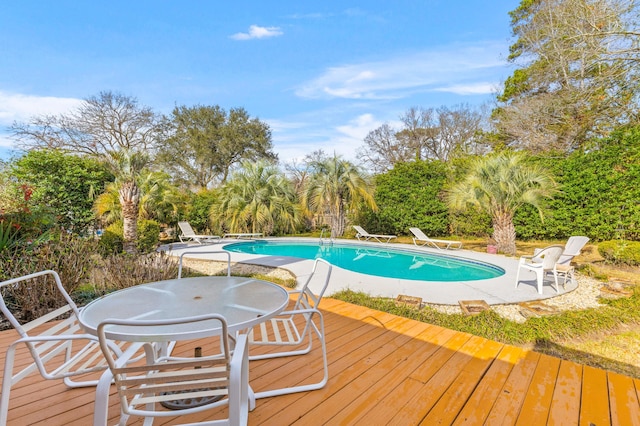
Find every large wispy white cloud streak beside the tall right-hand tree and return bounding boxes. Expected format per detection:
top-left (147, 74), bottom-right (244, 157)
top-left (296, 42), bottom-right (507, 99)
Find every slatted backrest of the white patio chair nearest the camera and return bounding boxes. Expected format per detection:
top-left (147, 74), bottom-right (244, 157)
top-left (98, 314), bottom-right (238, 416)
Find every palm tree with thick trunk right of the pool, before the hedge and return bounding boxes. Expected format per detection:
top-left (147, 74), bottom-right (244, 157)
top-left (447, 152), bottom-right (558, 255)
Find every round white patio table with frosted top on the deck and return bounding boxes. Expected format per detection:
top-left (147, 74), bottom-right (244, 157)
top-left (78, 276), bottom-right (289, 425)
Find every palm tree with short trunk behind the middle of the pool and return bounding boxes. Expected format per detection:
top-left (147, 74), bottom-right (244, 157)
top-left (302, 154), bottom-right (377, 236)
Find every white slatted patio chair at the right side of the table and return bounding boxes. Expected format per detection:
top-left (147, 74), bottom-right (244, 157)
top-left (249, 259), bottom-right (332, 398)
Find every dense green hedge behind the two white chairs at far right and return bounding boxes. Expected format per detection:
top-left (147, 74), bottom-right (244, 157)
top-left (514, 128), bottom-right (640, 241)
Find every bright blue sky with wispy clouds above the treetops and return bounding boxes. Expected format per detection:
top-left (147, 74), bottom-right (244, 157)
top-left (0, 0), bottom-right (519, 161)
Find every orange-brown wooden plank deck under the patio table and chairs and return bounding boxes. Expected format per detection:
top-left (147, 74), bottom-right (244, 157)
top-left (0, 299), bottom-right (640, 426)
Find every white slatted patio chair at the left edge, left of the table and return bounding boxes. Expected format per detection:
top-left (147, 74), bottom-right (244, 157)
top-left (0, 270), bottom-right (131, 425)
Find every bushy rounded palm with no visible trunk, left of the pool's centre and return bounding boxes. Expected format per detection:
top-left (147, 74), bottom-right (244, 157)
top-left (210, 160), bottom-right (300, 235)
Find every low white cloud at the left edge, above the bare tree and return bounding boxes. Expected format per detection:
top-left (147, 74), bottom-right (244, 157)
top-left (0, 91), bottom-right (82, 125)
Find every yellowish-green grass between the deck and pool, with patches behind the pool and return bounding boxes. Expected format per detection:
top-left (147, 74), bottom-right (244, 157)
top-left (332, 237), bottom-right (640, 378)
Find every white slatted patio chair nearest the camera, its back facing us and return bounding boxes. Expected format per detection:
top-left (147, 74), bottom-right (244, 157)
top-left (94, 314), bottom-right (249, 425)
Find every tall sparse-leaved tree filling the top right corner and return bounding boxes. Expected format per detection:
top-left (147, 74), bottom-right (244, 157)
top-left (494, 0), bottom-right (640, 151)
